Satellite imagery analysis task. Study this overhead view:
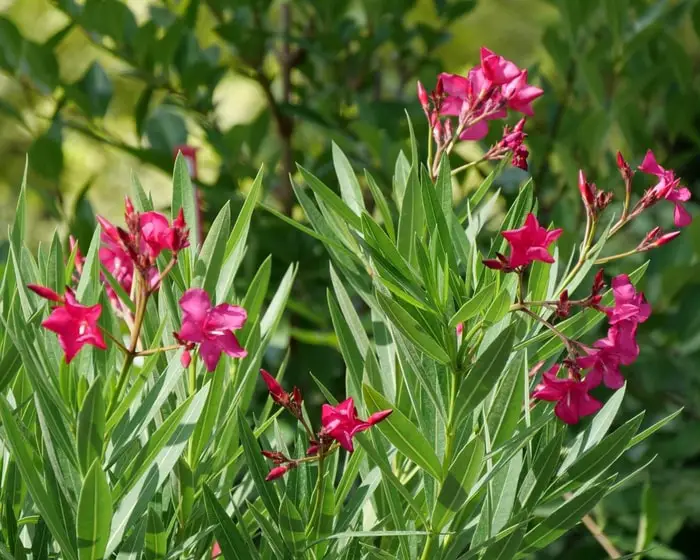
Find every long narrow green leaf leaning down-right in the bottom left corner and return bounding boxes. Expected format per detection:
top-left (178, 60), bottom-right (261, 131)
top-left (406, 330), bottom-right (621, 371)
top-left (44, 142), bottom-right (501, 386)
top-left (0, 396), bottom-right (77, 560)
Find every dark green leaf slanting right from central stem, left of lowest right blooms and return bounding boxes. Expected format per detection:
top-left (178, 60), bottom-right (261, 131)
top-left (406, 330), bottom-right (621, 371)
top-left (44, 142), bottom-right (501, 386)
top-left (455, 325), bottom-right (515, 426)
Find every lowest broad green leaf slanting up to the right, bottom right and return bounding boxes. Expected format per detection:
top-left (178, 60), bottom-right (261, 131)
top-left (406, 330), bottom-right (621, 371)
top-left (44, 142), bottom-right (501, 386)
top-left (521, 484), bottom-right (607, 553)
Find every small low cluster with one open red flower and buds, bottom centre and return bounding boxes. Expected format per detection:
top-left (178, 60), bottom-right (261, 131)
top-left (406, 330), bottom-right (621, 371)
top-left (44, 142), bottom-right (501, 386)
top-left (260, 369), bottom-right (392, 481)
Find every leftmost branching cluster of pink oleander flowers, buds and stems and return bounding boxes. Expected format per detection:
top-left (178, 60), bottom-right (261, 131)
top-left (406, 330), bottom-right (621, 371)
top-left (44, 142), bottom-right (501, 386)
top-left (29, 198), bottom-right (252, 372)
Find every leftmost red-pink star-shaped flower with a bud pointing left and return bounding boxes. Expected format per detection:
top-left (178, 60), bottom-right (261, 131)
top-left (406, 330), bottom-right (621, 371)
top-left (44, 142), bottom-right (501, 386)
top-left (34, 285), bottom-right (107, 364)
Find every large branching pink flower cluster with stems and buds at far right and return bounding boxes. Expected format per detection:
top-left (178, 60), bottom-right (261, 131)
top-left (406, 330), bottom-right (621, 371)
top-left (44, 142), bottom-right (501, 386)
top-left (482, 151), bottom-right (691, 424)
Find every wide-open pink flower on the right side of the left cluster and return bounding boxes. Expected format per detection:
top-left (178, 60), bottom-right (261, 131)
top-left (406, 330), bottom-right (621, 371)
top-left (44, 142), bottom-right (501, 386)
top-left (177, 288), bottom-right (247, 371)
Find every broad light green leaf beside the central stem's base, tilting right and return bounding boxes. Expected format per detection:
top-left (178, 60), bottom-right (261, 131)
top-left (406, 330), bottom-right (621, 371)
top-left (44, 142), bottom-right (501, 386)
top-left (431, 437), bottom-right (485, 531)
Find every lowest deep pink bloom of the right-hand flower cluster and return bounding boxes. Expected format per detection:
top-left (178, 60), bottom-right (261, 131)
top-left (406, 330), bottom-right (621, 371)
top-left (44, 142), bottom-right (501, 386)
top-left (532, 364), bottom-right (603, 424)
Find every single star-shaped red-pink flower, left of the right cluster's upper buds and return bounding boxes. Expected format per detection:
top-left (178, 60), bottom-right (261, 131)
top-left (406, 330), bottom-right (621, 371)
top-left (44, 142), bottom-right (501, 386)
top-left (484, 213), bottom-right (562, 271)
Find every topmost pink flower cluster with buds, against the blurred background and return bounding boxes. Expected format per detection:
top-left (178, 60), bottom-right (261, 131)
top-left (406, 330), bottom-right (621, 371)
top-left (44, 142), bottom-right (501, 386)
top-left (418, 47), bottom-right (543, 172)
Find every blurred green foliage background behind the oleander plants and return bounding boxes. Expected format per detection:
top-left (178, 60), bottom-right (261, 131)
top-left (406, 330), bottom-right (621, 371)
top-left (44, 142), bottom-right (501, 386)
top-left (0, 0), bottom-right (700, 558)
